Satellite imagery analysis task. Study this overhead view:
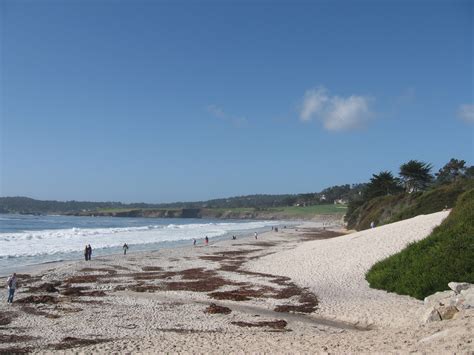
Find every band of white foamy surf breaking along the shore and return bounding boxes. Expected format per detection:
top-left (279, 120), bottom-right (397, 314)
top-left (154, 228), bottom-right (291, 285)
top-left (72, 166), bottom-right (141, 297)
top-left (0, 221), bottom-right (278, 258)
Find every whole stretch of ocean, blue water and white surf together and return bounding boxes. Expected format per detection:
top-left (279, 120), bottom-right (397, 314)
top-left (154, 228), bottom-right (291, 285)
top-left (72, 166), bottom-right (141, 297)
top-left (0, 214), bottom-right (291, 275)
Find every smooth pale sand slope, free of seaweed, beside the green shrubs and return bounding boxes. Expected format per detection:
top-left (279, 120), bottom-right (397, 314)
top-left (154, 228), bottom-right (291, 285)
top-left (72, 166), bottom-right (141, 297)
top-left (246, 212), bottom-right (449, 327)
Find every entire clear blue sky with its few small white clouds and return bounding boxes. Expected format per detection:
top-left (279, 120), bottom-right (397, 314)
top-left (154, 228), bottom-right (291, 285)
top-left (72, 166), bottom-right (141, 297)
top-left (0, 0), bottom-right (474, 203)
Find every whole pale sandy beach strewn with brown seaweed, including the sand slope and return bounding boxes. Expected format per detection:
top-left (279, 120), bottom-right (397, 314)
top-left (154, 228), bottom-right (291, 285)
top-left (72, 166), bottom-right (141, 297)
top-left (0, 212), bottom-right (474, 353)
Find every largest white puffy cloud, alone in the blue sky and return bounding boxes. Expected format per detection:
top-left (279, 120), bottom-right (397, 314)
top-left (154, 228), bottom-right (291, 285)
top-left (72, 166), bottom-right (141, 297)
top-left (298, 87), bottom-right (373, 131)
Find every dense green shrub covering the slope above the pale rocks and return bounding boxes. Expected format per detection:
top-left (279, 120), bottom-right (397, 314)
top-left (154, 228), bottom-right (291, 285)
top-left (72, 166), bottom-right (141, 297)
top-left (366, 189), bottom-right (474, 299)
